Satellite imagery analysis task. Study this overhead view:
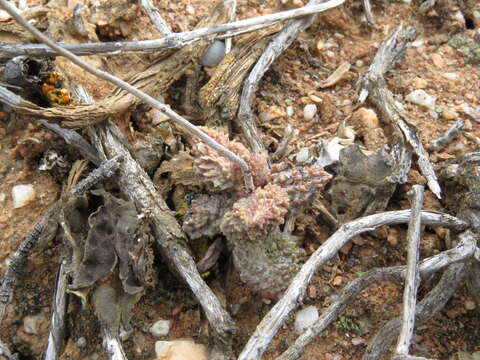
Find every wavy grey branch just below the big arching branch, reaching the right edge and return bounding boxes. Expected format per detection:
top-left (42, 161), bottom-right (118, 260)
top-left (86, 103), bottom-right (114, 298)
top-left (275, 230), bottom-right (478, 360)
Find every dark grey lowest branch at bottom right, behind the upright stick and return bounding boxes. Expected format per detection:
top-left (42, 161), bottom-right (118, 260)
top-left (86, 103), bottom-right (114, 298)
top-left (363, 262), bottom-right (465, 360)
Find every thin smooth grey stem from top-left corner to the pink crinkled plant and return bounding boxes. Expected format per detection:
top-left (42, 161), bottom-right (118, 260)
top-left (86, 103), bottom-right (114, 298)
top-left (0, 0), bottom-right (255, 191)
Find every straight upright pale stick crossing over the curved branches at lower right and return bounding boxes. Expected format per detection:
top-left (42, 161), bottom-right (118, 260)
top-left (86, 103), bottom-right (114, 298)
top-left (395, 185), bottom-right (423, 356)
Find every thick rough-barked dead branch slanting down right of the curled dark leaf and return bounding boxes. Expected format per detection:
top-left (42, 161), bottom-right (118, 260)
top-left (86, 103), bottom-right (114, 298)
top-left (92, 123), bottom-right (235, 358)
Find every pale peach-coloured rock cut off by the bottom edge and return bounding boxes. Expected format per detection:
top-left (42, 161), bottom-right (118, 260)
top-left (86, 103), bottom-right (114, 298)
top-left (155, 340), bottom-right (207, 360)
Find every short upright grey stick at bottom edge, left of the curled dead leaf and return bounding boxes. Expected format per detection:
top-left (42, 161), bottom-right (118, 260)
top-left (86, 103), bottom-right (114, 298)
top-left (43, 262), bottom-right (68, 360)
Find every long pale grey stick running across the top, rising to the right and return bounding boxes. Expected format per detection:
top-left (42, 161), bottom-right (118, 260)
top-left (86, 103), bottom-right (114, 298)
top-left (0, 0), bottom-right (345, 61)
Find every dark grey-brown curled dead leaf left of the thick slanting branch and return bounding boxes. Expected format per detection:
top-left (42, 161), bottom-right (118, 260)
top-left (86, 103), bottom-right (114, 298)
top-left (64, 191), bottom-right (148, 294)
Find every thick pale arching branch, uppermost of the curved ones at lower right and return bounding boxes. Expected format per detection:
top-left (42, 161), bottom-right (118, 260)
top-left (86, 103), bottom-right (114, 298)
top-left (239, 210), bottom-right (466, 360)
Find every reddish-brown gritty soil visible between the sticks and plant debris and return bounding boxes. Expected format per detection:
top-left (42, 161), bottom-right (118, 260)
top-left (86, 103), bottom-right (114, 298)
top-left (0, 0), bottom-right (480, 360)
